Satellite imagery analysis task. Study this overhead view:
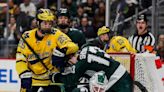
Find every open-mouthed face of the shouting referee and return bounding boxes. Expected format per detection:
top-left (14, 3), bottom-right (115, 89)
top-left (136, 20), bottom-right (147, 35)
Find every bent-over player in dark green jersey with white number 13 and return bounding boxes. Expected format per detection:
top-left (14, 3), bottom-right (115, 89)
top-left (50, 46), bottom-right (133, 92)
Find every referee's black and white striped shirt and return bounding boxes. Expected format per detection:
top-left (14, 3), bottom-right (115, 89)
top-left (128, 31), bottom-right (155, 53)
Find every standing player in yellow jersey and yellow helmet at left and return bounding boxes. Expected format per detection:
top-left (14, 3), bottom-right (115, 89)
top-left (16, 9), bottom-right (78, 92)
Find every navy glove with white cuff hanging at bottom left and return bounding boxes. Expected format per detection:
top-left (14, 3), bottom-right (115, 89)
top-left (20, 72), bottom-right (32, 92)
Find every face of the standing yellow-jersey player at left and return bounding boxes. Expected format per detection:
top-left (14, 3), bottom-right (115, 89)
top-left (40, 21), bottom-right (53, 33)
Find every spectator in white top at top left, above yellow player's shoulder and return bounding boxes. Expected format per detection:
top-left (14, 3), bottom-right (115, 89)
top-left (19, 0), bottom-right (36, 17)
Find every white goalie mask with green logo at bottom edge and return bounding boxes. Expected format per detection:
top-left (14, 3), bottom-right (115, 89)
top-left (89, 71), bottom-right (108, 92)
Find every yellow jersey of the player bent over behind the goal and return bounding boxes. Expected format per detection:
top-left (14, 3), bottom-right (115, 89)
top-left (106, 36), bottom-right (136, 53)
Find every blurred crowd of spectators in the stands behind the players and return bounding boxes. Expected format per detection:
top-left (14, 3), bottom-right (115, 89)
top-left (0, 0), bottom-right (162, 58)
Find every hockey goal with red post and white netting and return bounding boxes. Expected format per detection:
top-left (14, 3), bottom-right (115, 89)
top-left (109, 53), bottom-right (164, 92)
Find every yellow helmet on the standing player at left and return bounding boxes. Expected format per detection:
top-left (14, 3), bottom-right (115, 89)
top-left (36, 8), bottom-right (55, 21)
